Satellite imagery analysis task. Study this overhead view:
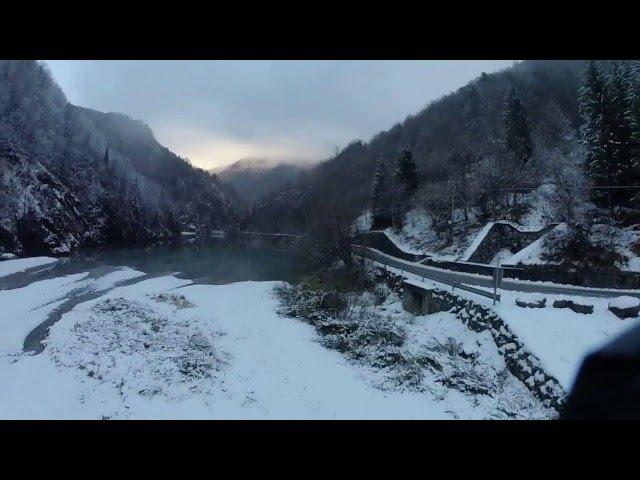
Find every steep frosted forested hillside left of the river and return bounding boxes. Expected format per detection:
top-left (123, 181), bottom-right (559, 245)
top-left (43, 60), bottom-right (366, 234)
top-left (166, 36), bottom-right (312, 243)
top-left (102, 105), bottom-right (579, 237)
top-left (0, 61), bottom-right (235, 253)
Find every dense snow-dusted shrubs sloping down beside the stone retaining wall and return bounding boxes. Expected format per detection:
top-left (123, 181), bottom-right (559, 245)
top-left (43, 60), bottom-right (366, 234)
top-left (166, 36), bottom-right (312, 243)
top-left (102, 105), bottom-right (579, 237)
top-left (277, 277), bottom-right (549, 418)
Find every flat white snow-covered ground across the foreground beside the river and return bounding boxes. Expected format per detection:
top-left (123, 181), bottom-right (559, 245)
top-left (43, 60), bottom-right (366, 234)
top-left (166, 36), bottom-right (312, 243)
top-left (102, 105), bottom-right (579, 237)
top-left (0, 256), bottom-right (549, 419)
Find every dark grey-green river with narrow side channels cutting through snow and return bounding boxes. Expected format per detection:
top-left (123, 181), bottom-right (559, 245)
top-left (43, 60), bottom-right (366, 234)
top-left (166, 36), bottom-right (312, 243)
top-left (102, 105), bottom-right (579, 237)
top-left (0, 242), bottom-right (304, 353)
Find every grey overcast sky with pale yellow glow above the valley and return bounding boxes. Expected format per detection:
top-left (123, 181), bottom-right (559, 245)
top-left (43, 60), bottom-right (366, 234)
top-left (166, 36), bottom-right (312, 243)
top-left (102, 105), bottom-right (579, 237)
top-left (47, 60), bottom-right (513, 168)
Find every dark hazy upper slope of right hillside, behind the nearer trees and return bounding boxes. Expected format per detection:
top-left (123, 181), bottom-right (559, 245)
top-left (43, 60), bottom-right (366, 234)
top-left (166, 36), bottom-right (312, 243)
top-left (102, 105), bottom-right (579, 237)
top-left (251, 61), bottom-right (583, 231)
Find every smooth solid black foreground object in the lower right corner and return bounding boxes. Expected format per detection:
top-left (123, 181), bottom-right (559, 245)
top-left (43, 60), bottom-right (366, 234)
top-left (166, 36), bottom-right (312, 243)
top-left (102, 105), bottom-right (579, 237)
top-left (560, 326), bottom-right (640, 420)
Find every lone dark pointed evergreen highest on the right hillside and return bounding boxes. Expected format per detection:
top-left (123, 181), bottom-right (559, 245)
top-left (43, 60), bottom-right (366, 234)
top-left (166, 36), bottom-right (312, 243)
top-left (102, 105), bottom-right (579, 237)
top-left (503, 87), bottom-right (533, 166)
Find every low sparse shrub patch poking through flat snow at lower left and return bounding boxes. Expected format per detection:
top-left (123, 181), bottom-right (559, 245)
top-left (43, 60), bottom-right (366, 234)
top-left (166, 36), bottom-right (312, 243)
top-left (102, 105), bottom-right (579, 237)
top-left (49, 298), bottom-right (227, 398)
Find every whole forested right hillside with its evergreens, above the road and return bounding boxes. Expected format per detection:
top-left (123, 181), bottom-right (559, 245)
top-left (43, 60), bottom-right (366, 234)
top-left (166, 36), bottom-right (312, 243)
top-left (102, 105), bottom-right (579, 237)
top-left (247, 61), bottom-right (640, 266)
